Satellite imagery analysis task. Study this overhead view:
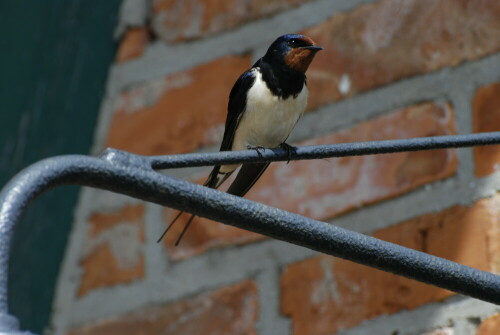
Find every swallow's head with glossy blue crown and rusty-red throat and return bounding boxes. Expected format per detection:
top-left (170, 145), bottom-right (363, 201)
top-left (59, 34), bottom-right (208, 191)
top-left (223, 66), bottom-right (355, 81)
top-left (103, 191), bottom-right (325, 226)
top-left (264, 34), bottom-right (323, 73)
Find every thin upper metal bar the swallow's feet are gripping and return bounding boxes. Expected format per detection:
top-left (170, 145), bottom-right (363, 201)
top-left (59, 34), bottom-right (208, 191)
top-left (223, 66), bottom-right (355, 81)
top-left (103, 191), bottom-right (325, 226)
top-left (143, 132), bottom-right (500, 169)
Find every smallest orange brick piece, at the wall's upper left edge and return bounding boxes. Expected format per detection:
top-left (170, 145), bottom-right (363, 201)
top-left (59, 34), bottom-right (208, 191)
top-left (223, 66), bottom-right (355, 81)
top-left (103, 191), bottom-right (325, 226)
top-left (116, 27), bottom-right (149, 63)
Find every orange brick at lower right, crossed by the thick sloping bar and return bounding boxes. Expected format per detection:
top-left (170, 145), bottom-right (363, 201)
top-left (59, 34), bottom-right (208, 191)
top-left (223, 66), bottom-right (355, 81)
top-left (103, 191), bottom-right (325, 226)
top-left (281, 195), bottom-right (500, 335)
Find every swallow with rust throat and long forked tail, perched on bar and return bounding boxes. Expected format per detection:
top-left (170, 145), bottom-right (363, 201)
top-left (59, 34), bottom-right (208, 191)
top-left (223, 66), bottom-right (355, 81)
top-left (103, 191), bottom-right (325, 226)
top-left (158, 34), bottom-right (323, 246)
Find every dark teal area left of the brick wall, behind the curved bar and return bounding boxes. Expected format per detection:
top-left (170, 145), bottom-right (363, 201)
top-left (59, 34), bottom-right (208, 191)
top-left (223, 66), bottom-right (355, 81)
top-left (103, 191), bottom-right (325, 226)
top-left (0, 0), bottom-right (121, 334)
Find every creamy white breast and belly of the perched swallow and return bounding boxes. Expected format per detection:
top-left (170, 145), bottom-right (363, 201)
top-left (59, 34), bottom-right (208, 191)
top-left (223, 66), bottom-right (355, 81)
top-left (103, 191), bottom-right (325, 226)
top-left (232, 70), bottom-right (308, 150)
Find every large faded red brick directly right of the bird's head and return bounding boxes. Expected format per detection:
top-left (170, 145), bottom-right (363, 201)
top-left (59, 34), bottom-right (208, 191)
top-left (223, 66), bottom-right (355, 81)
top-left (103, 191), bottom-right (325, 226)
top-left (304, 0), bottom-right (500, 107)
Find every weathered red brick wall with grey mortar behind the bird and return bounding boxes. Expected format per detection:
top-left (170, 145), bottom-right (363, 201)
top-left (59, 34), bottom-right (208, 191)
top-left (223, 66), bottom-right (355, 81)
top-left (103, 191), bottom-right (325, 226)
top-left (52, 0), bottom-right (500, 335)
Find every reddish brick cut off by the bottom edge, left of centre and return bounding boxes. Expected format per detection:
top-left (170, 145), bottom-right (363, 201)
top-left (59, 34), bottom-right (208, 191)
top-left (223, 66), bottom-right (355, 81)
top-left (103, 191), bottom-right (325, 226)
top-left (69, 281), bottom-right (258, 335)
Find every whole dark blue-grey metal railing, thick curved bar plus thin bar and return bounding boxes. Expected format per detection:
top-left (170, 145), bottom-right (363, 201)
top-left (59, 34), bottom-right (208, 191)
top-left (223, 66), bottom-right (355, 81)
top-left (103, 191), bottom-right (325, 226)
top-left (0, 132), bottom-right (500, 334)
